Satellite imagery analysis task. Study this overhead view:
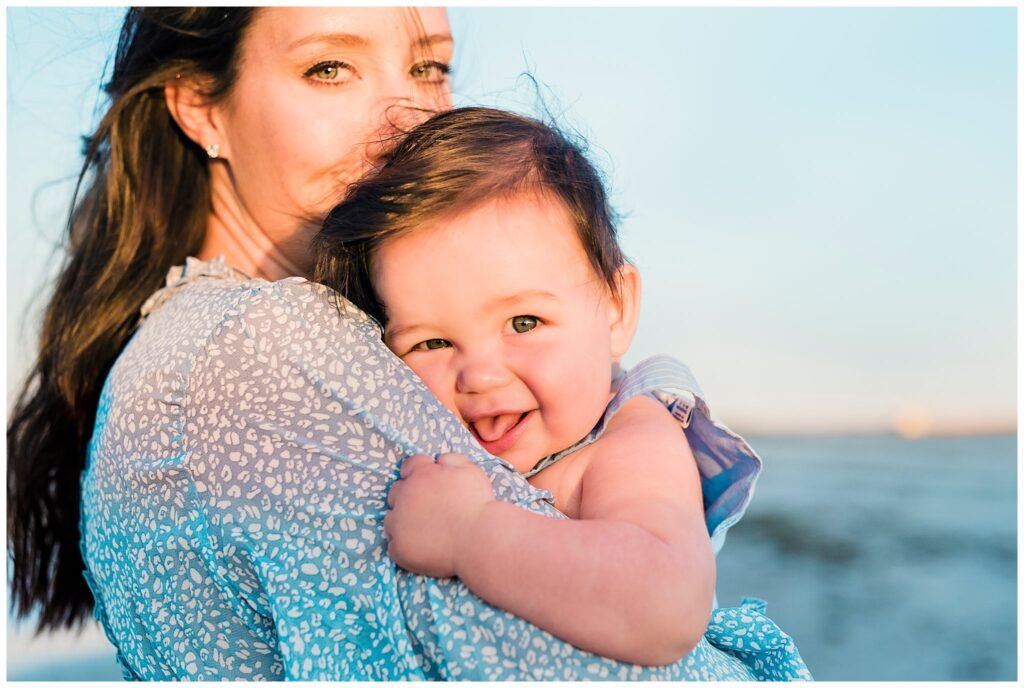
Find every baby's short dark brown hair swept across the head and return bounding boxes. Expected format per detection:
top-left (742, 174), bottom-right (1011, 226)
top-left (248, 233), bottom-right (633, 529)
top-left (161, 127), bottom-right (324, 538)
top-left (312, 108), bottom-right (627, 325)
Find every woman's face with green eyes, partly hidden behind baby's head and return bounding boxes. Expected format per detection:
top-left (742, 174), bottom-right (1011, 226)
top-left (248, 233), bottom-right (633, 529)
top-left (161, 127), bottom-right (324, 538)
top-left (213, 7), bottom-right (453, 255)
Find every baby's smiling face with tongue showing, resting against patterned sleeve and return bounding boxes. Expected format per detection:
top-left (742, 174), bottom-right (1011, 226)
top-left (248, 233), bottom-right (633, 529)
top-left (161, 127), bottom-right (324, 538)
top-left (373, 194), bottom-right (632, 471)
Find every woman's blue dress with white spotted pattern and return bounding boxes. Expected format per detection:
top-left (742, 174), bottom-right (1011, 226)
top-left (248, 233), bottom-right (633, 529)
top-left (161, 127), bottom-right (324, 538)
top-left (81, 259), bottom-right (810, 680)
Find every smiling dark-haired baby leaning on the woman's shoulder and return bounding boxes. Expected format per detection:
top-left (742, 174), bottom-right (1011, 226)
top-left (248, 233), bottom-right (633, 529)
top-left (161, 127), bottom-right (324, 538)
top-left (314, 109), bottom-right (729, 664)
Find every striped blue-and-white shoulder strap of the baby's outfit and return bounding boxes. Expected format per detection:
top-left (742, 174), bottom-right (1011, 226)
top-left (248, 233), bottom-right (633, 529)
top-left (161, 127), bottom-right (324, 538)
top-left (524, 355), bottom-right (762, 554)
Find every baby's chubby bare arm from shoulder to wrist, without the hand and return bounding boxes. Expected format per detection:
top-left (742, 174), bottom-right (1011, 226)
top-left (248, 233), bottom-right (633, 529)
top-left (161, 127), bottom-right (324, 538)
top-left (456, 397), bottom-right (715, 664)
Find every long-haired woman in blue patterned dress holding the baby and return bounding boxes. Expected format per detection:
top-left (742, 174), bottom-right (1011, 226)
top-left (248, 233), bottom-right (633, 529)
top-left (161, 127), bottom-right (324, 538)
top-left (8, 8), bottom-right (806, 679)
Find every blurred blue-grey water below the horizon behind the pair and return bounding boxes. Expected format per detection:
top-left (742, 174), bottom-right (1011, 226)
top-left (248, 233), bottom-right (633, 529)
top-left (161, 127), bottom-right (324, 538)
top-left (7, 436), bottom-right (1017, 681)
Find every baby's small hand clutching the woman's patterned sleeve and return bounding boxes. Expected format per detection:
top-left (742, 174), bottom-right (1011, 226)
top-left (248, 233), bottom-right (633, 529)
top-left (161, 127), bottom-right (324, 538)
top-left (384, 454), bottom-right (495, 578)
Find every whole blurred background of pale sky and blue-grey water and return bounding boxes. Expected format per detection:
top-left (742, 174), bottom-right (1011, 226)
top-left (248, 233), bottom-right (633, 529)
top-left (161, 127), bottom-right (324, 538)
top-left (6, 7), bottom-right (1018, 681)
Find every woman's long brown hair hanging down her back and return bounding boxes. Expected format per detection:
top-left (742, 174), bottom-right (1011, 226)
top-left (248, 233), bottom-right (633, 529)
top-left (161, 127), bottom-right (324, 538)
top-left (7, 7), bottom-right (257, 630)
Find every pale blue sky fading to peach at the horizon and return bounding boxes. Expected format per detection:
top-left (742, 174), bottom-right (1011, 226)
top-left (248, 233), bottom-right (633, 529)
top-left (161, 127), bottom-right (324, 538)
top-left (6, 7), bottom-right (1018, 435)
